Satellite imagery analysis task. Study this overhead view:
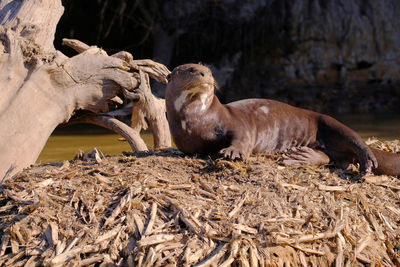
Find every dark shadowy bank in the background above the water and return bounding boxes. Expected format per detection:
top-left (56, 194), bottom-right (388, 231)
top-left (55, 0), bottom-right (400, 114)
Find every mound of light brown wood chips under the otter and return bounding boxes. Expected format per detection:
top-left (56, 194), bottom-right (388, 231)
top-left (0, 140), bottom-right (400, 266)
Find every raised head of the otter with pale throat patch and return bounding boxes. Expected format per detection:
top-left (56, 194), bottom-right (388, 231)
top-left (166, 64), bottom-right (215, 112)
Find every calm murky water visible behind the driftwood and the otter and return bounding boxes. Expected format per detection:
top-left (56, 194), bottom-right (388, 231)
top-left (37, 114), bottom-right (400, 163)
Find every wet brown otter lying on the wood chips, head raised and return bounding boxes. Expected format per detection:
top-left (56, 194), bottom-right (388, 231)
top-left (165, 64), bottom-right (400, 175)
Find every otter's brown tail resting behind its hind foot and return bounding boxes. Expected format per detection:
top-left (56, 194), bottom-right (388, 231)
top-left (370, 147), bottom-right (400, 176)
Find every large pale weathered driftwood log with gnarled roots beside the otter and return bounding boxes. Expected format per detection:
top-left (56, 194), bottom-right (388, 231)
top-left (0, 0), bottom-right (171, 181)
